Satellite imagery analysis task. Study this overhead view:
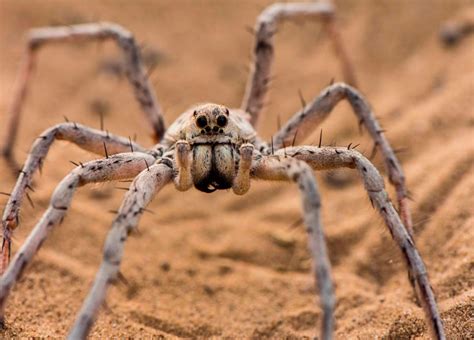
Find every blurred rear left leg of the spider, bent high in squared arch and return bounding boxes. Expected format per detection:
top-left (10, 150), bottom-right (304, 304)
top-left (2, 22), bottom-right (165, 164)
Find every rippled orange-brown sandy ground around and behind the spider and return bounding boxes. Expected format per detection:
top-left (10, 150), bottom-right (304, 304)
top-left (0, 0), bottom-right (474, 339)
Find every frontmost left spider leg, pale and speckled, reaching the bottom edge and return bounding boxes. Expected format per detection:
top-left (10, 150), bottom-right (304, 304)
top-left (69, 158), bottom-right (173, 339)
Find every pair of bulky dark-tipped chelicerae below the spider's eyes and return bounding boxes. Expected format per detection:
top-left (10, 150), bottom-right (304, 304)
top-left (191, 144), bottom-right (235, 192)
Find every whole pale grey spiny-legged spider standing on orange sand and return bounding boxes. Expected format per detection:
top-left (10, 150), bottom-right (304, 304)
top-left (0, 3), bottom-right (445, 339)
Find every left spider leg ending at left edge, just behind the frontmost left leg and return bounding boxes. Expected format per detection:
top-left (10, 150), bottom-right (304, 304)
top-left (0, 152), bottom-right (155, 322)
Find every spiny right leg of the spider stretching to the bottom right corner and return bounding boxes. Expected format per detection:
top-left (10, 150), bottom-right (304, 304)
top-left (275, 146), bottom-right (446, 339)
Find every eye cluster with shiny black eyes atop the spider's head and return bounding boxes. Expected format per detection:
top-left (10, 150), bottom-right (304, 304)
top-left (193, 104), bottom-right (229, 136)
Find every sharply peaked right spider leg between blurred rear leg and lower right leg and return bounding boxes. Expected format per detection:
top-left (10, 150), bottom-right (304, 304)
top-left (273, 83), bottom-right (413, 236)
